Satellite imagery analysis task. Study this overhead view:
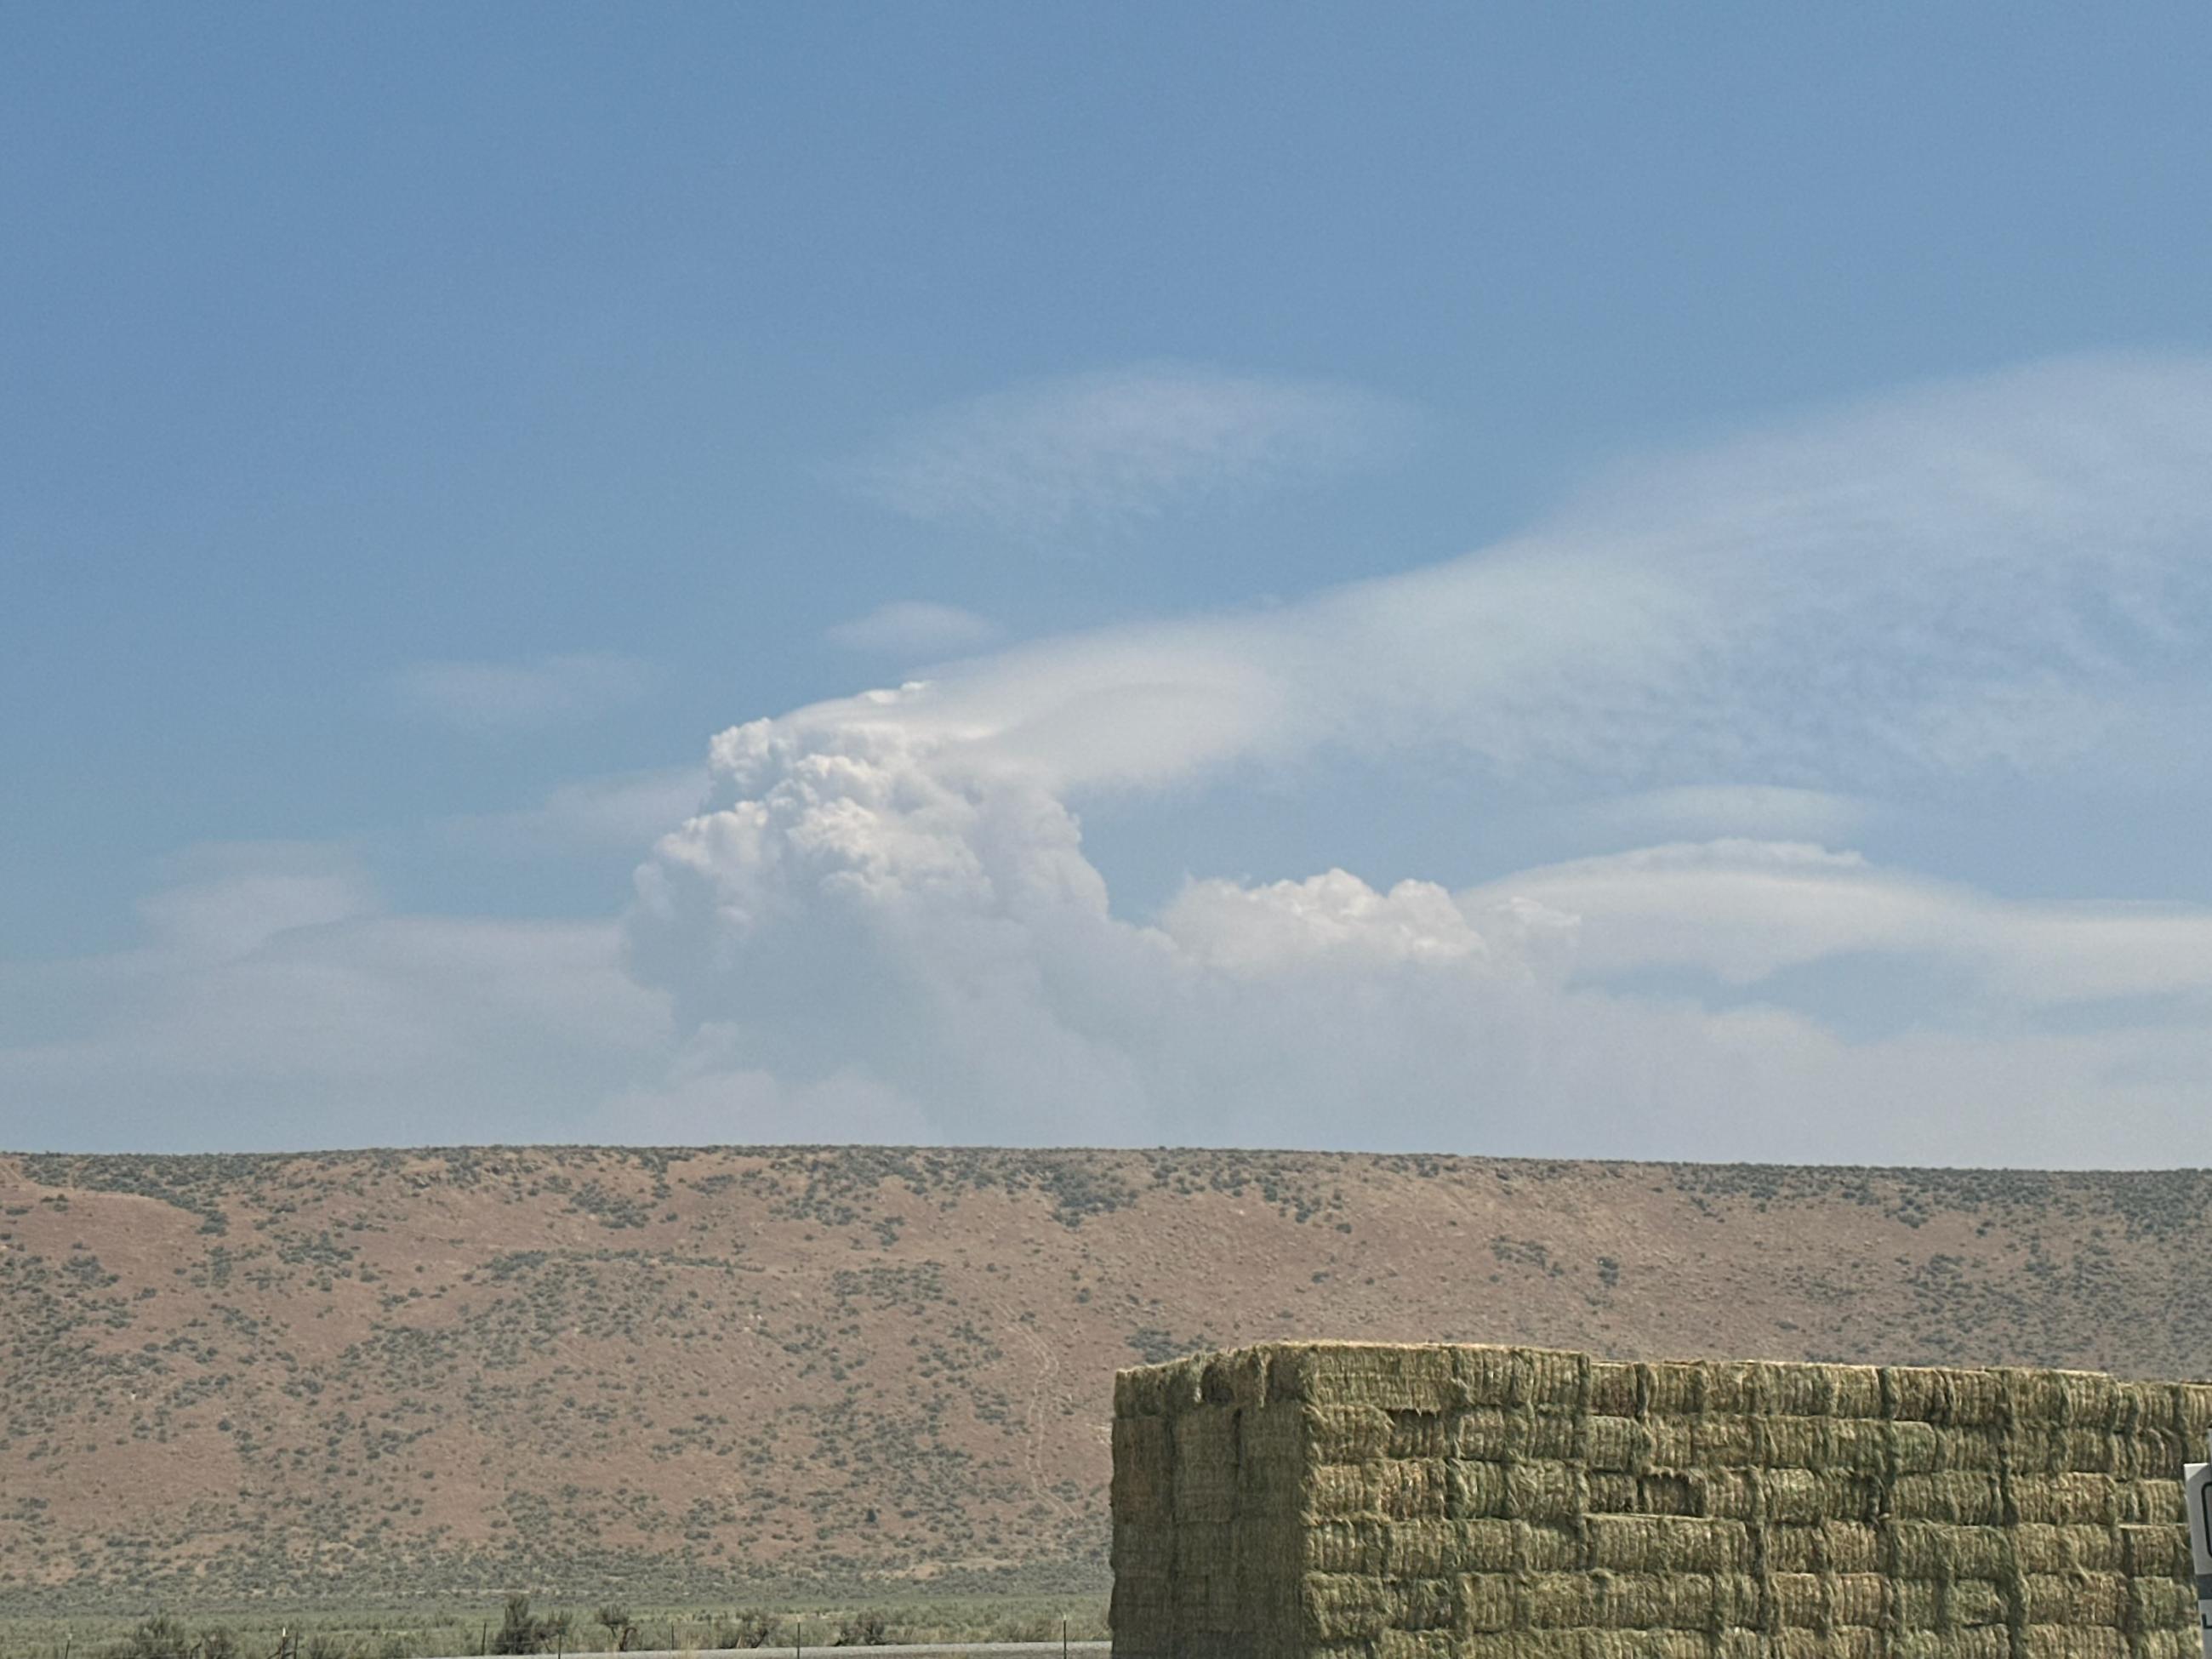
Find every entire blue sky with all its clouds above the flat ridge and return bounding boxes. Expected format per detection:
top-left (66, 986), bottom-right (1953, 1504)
top-left (0, 4), bottom-right (2212, 1164)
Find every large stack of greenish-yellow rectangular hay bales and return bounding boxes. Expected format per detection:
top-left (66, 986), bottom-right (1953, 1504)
top-left (1113, 1343), bottom-right (2212, 1659)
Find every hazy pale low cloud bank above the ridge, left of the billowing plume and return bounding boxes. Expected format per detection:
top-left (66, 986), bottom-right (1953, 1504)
top-left (0, 845), bottom-right (668, 1150)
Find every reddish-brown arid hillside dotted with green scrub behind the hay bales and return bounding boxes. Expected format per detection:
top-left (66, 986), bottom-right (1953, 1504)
top-left (0, 1148), bottom-right (2212, 1606)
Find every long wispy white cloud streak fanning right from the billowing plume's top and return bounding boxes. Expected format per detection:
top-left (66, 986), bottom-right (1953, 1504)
top-left (778, 358), bottom-right (2212, 796)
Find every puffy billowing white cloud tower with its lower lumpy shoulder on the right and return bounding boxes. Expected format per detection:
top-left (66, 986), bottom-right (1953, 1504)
top-left (630, 721), bottom-right (1571, 1142)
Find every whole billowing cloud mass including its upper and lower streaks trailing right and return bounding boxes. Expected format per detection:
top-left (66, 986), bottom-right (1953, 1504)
top-left (628, 362), bottom-right (2212, 1161)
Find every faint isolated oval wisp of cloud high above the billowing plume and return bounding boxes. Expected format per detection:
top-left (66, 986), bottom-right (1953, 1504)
top-left (845, 362), bottom-right (1411, 535)
